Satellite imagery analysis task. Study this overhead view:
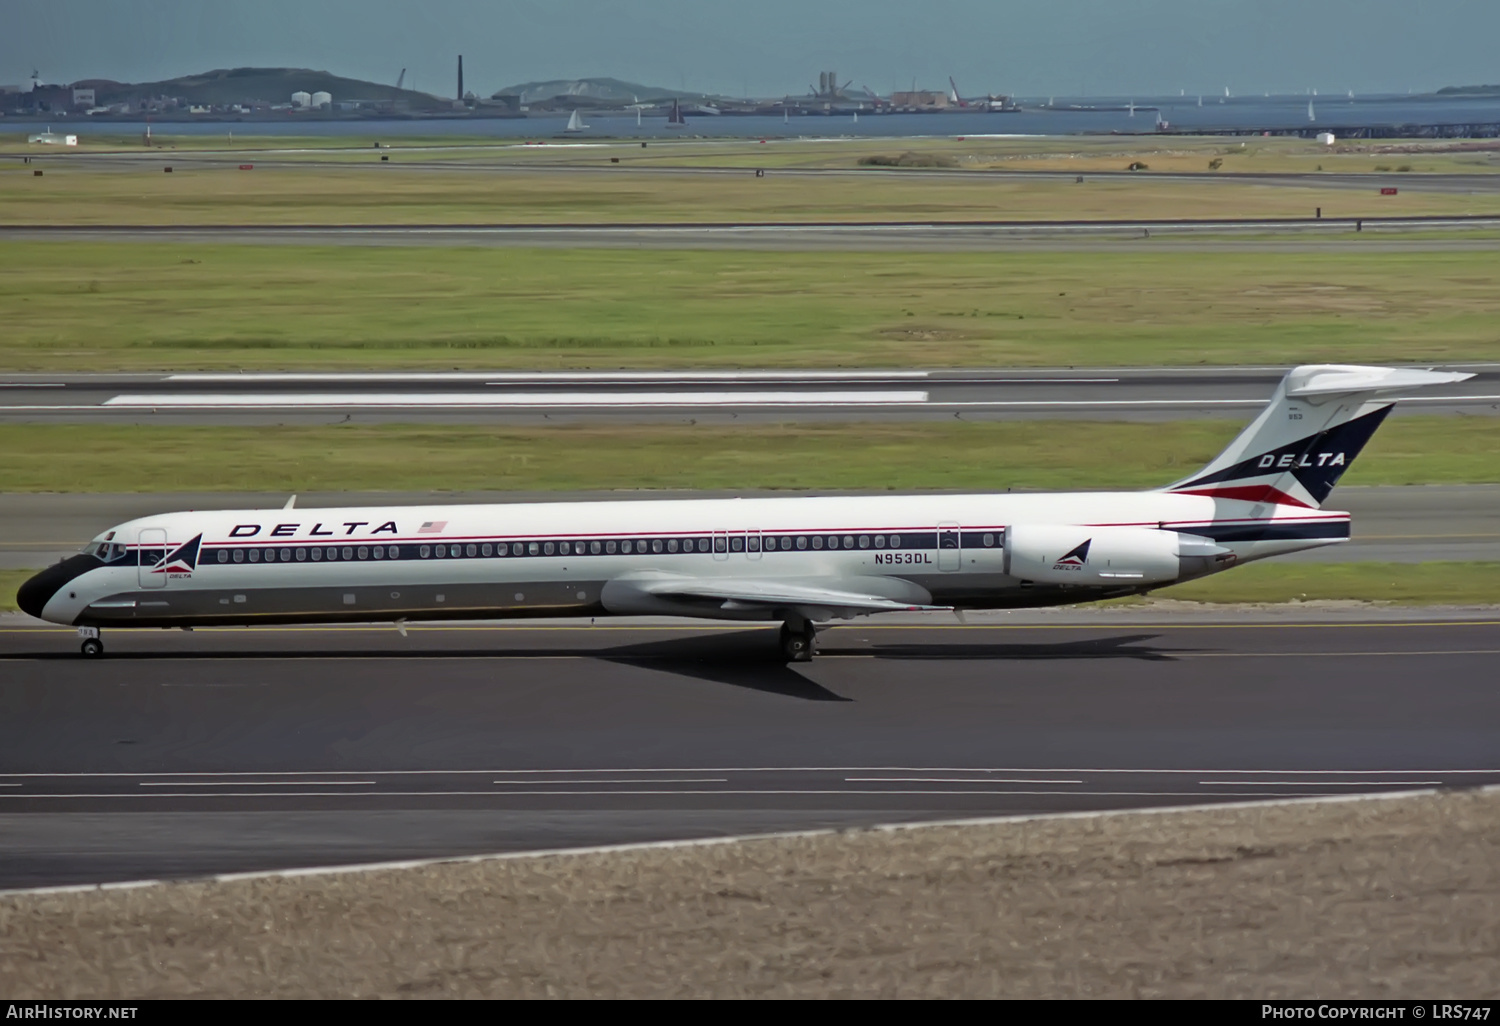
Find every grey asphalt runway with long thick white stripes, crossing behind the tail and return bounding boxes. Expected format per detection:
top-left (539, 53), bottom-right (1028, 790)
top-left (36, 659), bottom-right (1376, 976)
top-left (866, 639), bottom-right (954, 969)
top-left (0, 363), bottom-right (1500, 425)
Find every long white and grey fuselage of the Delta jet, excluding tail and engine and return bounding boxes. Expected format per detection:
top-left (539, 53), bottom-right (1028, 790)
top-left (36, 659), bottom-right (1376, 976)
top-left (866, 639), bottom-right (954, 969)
top-left (33, 492), bottom-right (1349, 627)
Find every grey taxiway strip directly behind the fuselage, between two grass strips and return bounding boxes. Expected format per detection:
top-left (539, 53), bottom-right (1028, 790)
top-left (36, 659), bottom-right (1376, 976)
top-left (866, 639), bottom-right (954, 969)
top-left (0, 476), bottom-right (1500, 570)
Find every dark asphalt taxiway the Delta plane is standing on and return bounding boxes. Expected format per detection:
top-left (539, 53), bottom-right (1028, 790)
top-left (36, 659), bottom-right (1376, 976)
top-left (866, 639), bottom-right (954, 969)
top-left (0, 611), bottom-right (1500, 887)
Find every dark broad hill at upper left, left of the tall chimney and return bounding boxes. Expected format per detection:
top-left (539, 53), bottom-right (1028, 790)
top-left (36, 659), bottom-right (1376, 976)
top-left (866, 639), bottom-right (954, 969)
top-left (74, 68), bottom-right (447, 108)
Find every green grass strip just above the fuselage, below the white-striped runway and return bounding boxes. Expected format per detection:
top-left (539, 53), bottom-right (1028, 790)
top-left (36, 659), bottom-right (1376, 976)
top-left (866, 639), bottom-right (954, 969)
top-left (0, 416), bottom-right (1500, 492)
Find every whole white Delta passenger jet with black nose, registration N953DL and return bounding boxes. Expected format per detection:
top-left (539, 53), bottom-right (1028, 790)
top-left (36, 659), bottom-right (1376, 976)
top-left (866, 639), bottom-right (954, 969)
top-left (17, 365), bottom-right (1473, 662)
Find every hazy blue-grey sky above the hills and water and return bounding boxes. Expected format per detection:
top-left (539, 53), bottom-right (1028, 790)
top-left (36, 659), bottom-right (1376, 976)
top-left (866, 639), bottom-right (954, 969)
top-left (0, 0), bottom-right (1500, 96)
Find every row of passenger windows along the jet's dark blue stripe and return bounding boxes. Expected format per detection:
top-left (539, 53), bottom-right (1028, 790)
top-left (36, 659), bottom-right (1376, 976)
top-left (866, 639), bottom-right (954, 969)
top-left (216, 533), bottom-right (1004, 563)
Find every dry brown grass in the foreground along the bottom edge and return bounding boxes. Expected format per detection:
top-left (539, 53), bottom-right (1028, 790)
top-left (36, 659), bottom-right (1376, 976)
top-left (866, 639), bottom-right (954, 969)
top-left (0, 792), bottom-right (1500, 999)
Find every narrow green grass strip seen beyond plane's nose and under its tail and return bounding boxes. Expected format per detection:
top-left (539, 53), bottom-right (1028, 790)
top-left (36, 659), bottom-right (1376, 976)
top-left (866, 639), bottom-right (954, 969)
top-left (11, 561), bottom-right (1500, 612)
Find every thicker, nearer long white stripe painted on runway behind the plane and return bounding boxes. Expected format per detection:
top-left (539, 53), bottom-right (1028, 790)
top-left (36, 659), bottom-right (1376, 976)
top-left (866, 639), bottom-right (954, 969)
top-left (102, 392), bottom-right (924, 410)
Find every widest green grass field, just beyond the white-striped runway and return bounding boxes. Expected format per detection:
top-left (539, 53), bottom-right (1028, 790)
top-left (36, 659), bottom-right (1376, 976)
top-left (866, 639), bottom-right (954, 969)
top-left (0, 242), bottom-right (1500, 371)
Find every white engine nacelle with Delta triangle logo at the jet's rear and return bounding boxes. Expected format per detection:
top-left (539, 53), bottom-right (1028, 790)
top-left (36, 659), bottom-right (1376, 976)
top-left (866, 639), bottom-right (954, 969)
top-left (1005, 524), bottom-right (1197, 587)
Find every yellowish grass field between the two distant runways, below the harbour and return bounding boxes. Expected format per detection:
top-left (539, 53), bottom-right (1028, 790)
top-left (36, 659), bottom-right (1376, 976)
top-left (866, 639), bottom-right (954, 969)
top-left (0, 162), bottom-right (1500, 225)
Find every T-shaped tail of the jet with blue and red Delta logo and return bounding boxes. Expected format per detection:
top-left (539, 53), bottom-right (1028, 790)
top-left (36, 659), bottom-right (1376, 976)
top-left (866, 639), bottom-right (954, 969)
top-left (1164, 365), bottom-right (1473, 509)
